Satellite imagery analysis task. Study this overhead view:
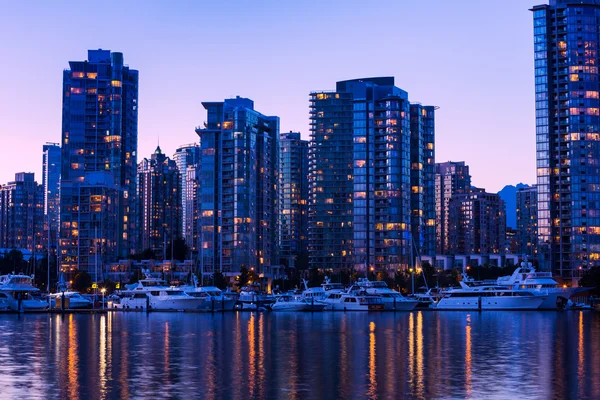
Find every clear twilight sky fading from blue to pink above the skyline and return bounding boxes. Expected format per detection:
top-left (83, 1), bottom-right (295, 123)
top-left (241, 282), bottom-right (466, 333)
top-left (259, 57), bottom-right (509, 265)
top-left (0, 0), bottom-right (544, 192)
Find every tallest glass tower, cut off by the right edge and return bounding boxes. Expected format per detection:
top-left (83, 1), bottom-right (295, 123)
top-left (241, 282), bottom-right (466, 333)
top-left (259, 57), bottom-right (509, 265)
top-left (532, 0), bottom-right (600, 278)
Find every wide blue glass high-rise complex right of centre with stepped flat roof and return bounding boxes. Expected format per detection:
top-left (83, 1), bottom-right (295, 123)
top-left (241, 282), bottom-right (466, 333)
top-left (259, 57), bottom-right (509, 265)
top-left (309, 77), bottom-right (435, 272)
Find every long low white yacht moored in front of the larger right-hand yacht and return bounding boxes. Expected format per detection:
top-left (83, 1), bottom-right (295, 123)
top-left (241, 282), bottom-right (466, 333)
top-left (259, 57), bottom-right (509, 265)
top-left (432, 282), bottom-right (547, 310)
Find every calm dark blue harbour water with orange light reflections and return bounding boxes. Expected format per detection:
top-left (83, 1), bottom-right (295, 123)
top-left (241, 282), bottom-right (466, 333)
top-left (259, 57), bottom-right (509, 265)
top-left (0, 312), bottom-right (600, 399)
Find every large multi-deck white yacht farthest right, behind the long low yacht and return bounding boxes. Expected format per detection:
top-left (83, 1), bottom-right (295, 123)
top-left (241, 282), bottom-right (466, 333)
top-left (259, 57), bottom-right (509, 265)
top-left (497, 260), bottom-right (588, 310)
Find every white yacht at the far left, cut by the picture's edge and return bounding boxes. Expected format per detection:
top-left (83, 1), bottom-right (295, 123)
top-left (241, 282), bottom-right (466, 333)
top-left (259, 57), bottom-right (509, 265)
top-left (0, 274), bottom-right (48, 312)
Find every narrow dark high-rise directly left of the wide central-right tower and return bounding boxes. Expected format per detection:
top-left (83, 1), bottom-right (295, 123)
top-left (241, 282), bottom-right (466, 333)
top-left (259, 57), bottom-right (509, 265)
top-left (279, 132), bottom-right (308, 268)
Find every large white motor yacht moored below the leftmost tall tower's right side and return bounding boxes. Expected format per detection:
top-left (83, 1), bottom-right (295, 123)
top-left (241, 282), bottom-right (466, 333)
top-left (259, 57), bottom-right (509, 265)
top-left (115, 287), bottom-right (211, 311)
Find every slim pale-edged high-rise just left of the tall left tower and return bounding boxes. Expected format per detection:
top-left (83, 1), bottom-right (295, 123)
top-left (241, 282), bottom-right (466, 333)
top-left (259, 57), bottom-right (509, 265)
top-left (42, 143), bottom-right (61, 247)
